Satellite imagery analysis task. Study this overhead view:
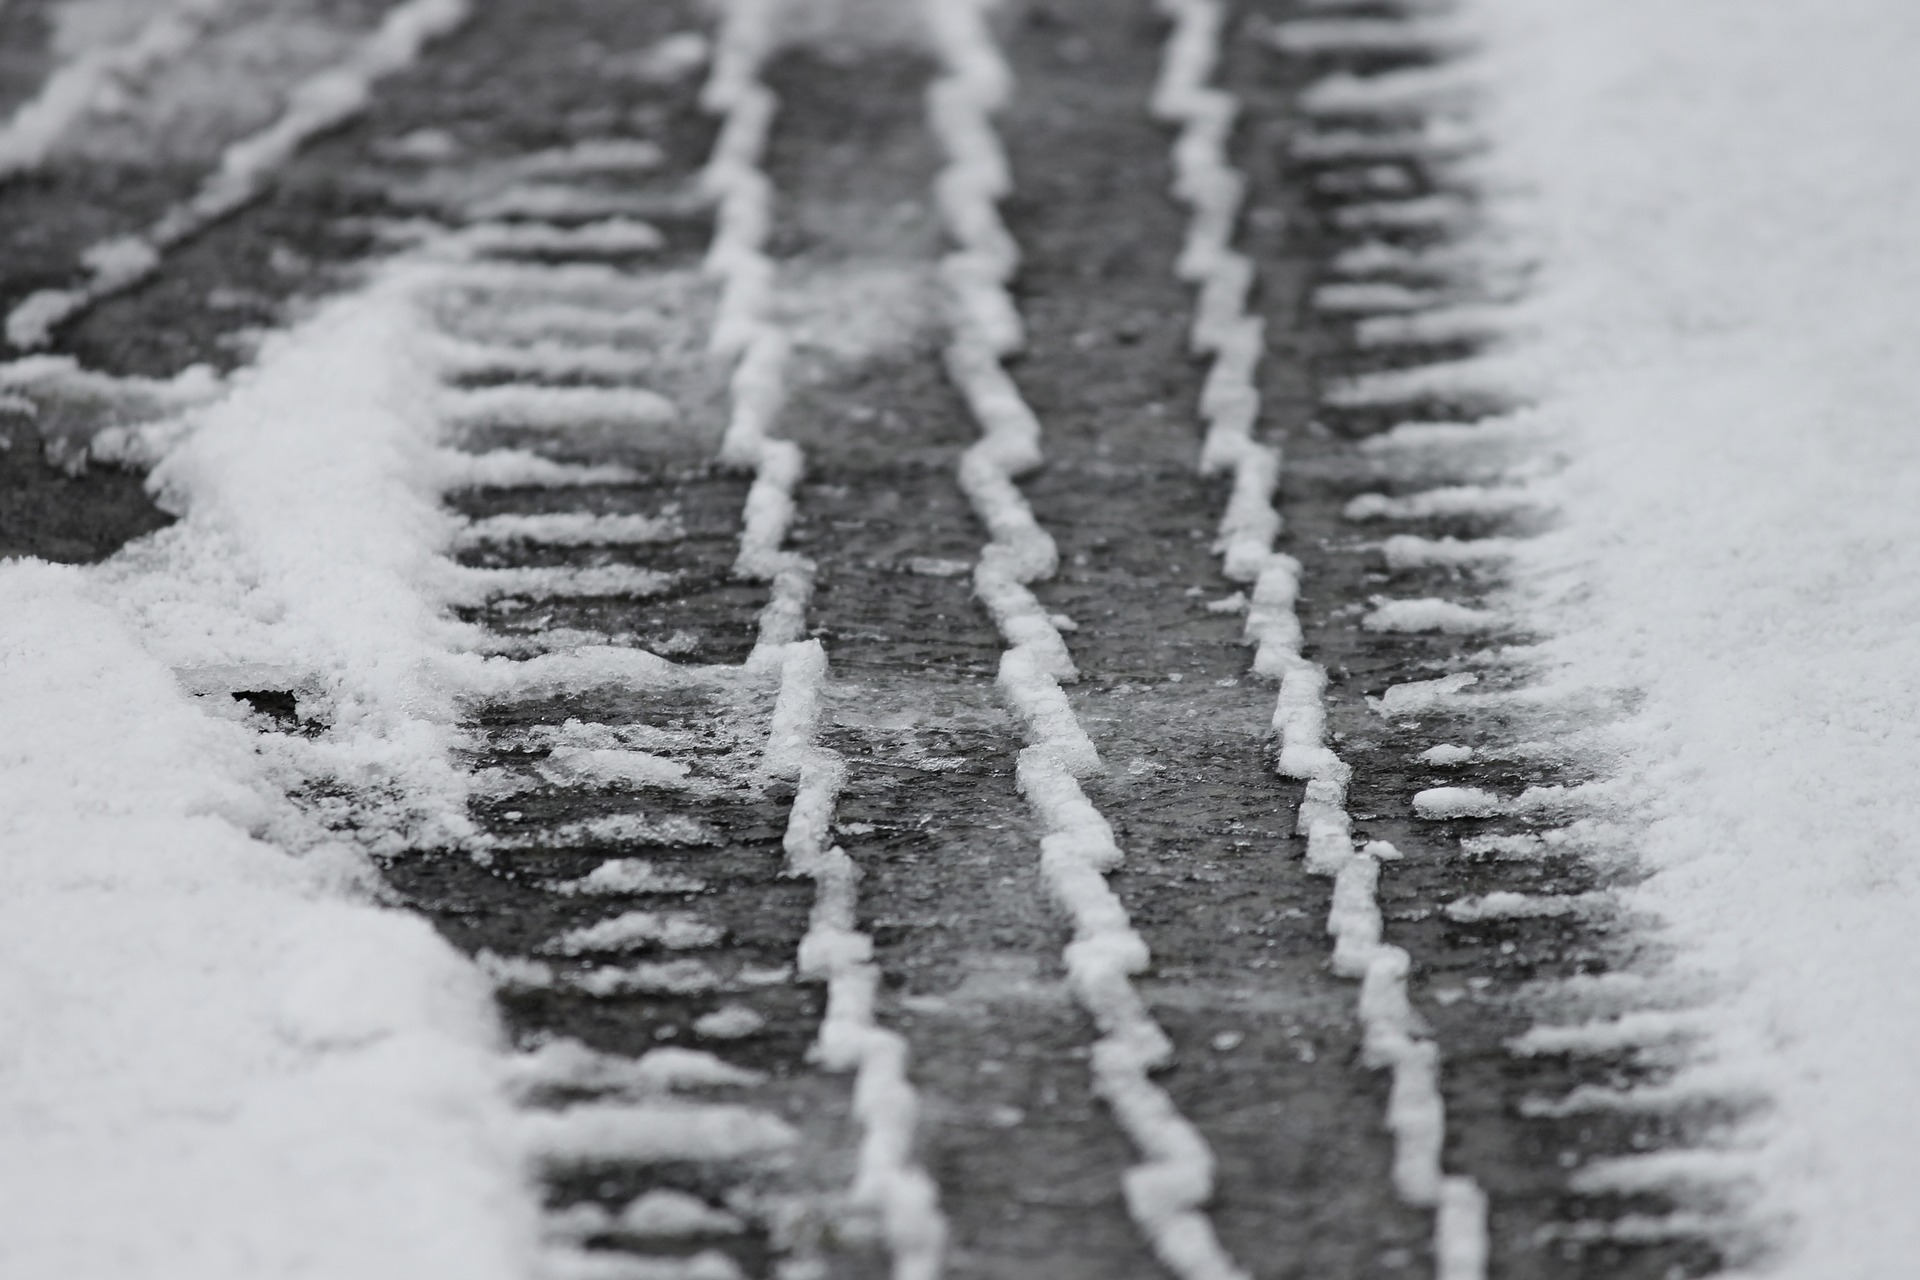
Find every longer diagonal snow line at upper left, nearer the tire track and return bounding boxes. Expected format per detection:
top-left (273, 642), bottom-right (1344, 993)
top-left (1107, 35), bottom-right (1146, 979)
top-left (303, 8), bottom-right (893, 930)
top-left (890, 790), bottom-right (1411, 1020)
top-left (6, 0), bottom-right (468, 349)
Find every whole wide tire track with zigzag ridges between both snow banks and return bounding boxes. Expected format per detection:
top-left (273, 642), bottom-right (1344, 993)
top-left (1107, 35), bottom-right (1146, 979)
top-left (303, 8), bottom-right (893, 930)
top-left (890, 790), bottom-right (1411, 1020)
top-left (8, 0), bottom-right (1743, 1280)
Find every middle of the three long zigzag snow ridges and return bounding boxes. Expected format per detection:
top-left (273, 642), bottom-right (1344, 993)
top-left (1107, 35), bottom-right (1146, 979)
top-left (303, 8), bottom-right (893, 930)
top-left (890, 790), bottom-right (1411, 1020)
top-left (925, 0), bottom-right (1246, 1280)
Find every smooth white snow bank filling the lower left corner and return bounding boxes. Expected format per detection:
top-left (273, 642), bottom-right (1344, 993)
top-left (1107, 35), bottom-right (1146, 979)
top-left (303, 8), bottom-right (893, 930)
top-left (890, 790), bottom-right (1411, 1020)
top-left (0, 562), bottom-right (534, 1280)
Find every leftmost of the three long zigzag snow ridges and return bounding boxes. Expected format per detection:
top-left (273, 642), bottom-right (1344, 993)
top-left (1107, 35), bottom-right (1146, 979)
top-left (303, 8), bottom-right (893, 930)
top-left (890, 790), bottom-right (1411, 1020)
top-left (701, 0), bottom-right (947, 1280)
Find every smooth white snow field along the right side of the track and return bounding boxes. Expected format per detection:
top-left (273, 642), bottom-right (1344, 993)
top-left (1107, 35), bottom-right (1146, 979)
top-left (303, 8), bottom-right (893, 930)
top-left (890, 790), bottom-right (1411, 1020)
top-left (1467, 0), bottom-right (1920, 1280)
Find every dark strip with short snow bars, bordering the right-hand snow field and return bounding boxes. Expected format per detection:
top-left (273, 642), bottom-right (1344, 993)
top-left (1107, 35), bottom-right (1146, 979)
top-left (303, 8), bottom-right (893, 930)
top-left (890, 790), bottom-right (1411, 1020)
top-left (1269, 6), bottom-right (1751, 1276)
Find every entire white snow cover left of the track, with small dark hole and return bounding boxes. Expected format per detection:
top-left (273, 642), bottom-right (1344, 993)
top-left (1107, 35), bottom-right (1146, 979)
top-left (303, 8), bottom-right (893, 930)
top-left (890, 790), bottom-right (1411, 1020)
top-left (0, 280), bottom-right (536, 1280)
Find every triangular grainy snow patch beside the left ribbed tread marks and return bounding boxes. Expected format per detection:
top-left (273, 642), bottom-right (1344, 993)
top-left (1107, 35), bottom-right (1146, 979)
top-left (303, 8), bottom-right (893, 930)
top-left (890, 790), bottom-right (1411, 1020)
top-left (98, 265), bottom-right (478, 846)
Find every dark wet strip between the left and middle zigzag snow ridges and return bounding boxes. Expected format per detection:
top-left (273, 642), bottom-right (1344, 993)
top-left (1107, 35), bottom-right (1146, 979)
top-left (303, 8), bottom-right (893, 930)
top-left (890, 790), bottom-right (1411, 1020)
top-left (770, 35), bottom-right (1158, 1280)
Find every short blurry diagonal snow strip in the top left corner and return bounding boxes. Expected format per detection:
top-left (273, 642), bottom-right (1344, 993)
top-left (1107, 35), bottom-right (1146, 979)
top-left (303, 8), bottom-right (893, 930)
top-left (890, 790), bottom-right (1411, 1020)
top-left (0, 0), bottom-right (230, 182)
